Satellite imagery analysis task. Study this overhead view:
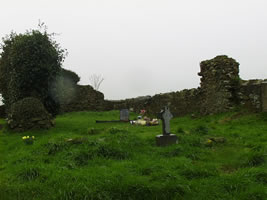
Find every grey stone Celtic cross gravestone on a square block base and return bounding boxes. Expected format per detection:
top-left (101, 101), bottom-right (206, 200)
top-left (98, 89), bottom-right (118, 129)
top-left (156, 106), bottom-right (178, 146)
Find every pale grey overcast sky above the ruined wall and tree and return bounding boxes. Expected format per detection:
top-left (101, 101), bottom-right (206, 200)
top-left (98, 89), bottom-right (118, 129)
top-left (0, 0), bottom-right (267, 99)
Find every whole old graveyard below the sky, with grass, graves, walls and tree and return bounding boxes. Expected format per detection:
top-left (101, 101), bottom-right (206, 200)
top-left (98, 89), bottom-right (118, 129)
top-left (0, 25), bottom-right (267, 200)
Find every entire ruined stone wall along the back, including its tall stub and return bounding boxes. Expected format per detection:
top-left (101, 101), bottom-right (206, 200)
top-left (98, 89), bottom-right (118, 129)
top-left (0, 56), bottom-right (267, 116)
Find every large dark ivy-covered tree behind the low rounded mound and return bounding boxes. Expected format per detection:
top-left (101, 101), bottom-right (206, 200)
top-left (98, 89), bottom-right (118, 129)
top-left (0, 27), bottom-right (66, 115)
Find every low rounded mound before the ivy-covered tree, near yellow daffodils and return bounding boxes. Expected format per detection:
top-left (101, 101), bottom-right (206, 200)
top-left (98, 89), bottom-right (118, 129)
top-left (8, 97), bottom-right (53, 131)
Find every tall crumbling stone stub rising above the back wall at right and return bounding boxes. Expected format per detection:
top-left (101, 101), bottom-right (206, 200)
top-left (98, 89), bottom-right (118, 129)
top-left (198, 56), bottom-right (240, 114)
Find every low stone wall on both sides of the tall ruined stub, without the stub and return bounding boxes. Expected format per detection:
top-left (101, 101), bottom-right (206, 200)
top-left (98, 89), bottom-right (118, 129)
top-left (106, 80), bottom-right (267, 117)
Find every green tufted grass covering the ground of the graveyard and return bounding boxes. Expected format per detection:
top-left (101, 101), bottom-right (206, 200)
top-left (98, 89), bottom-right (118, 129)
top-left (0, 111), bottom-right (267, 200)
